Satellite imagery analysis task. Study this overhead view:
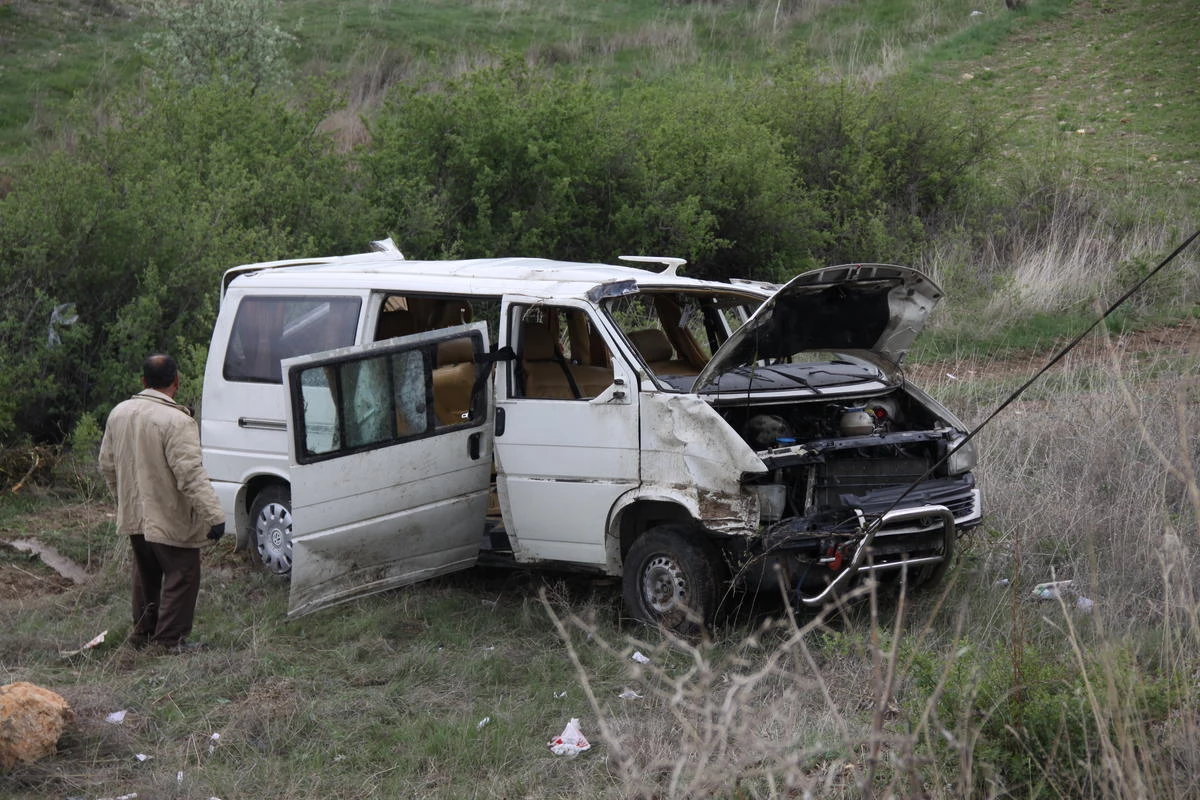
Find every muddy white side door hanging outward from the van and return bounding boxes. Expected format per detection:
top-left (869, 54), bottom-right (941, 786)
top-left (283, 323), bottom-right (494, 616)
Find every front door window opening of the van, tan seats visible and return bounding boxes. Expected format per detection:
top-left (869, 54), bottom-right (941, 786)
top-left (514, 306), bottom-right (612, 399)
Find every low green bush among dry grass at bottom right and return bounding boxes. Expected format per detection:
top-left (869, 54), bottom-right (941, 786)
top-left (904, 642), bottom-right (1180, 798)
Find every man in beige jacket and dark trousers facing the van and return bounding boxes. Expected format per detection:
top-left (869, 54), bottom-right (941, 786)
top-left (100, 353), bottom-right (224, 652)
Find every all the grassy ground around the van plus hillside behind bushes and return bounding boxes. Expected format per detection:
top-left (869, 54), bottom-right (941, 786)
top-left (0, 0), bottom-right (1200, 800)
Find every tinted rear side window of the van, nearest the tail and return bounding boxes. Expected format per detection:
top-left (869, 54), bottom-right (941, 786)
top-left (223, 296), bottom-right (362, 384)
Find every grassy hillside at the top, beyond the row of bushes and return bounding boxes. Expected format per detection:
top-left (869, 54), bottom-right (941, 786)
top-left (0, 0), bottom-right (1200, 210)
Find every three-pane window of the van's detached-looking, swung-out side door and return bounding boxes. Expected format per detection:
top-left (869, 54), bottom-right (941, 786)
top-left (292, 336), bottom-right (487, 463)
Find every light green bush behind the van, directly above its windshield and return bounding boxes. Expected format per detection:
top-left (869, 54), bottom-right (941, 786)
top-left (618, 78), bottom-right (828, 279)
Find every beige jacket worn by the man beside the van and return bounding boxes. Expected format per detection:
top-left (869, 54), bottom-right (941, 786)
top-left (100, 389), bottom-right (224, 547)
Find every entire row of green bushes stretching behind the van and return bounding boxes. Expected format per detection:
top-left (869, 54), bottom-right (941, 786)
top-left (0, 64), bottom-right (985, 441)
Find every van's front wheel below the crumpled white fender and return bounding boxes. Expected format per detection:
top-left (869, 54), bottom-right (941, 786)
top-left (622, 525), bottom-right (720, 636)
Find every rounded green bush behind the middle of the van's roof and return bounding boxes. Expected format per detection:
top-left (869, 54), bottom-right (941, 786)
top-left (364, 67), bottom-right (629, 259)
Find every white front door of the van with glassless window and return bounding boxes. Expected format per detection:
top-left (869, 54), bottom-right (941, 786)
top-left (496, 295), bottom-right (641, 573)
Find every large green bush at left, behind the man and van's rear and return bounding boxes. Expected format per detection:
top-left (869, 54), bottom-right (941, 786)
top-left (0, 84), bottom-right (367, 440)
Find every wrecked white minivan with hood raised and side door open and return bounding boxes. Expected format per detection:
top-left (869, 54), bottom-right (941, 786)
top-left (200, 240), bottom-right (980, 632)
